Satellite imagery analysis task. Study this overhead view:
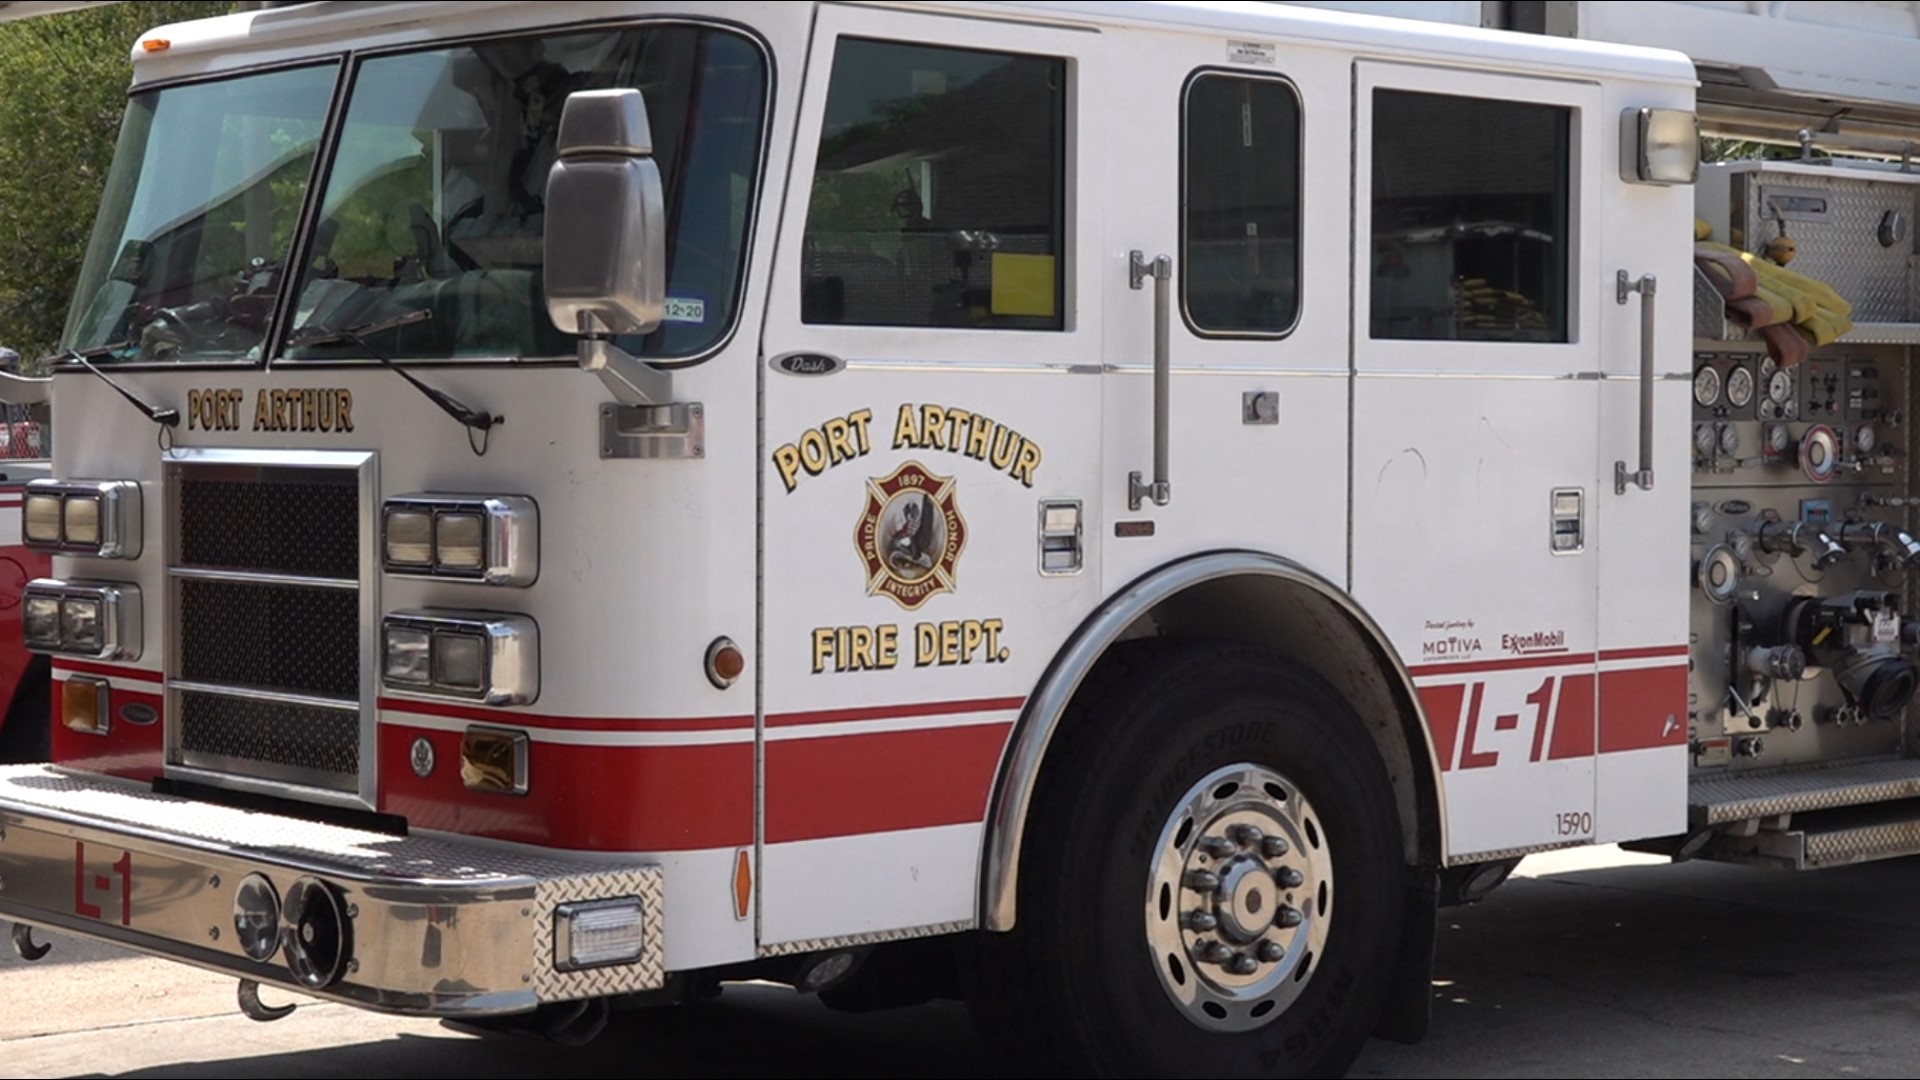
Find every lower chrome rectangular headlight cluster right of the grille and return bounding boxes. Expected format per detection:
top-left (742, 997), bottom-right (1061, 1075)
top-left (380, 609), bottom-right (540, 705)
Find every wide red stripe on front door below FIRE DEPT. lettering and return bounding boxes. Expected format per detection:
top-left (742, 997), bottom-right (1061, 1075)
top-left (766, 723), bottom-right (1014, 844)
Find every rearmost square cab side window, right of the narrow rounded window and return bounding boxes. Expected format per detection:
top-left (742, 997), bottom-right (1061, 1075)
top-left (1371, 90), bottom-right (1572, 342)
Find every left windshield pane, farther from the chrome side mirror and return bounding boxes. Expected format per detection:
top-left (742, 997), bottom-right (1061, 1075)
top-left (67, 63), bottom-right (338, 361)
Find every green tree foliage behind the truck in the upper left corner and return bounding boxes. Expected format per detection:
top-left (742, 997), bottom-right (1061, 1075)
top-left (0, 0), bottom-right (240, 357)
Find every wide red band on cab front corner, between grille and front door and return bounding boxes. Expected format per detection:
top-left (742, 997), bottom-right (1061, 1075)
top-left (380, 724), bottom-right (753, 849)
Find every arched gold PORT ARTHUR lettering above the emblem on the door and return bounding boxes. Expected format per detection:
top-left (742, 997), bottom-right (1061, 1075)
top-left (774, 402), bottom-right (1043, 494)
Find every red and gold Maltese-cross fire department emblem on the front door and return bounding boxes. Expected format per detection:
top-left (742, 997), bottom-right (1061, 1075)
top-left (852, 461), bottom-right (966, 611)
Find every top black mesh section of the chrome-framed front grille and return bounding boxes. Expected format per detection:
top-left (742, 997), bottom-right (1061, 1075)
top-left (179, 469), bottom-right (359, 578)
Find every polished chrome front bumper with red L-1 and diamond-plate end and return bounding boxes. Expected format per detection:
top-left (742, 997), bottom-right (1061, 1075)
top-left (0, 765), bottom-right (666, 1017)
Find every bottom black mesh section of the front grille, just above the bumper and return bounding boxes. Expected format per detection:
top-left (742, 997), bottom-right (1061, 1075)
top-left (180, 692), bottom-right (359, 786)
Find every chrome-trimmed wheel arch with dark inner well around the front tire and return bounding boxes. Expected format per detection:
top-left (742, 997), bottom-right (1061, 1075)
top-left (981, 552), bottom-right (1446, 930)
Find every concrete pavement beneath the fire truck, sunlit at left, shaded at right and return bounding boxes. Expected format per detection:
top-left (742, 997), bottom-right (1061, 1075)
top-left (0, 847), bottom-right (1920, 1080)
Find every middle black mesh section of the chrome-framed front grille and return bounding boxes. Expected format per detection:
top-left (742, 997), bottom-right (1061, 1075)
top-left (180, 578), bottom-right (361, 700)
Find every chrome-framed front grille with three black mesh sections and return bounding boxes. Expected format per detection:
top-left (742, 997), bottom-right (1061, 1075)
top-left (167, 452), bottom-right (372, 798)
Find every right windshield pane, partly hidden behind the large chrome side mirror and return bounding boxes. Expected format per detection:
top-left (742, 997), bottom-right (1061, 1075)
top-left (286, 25), bottom-right (766, 359)
